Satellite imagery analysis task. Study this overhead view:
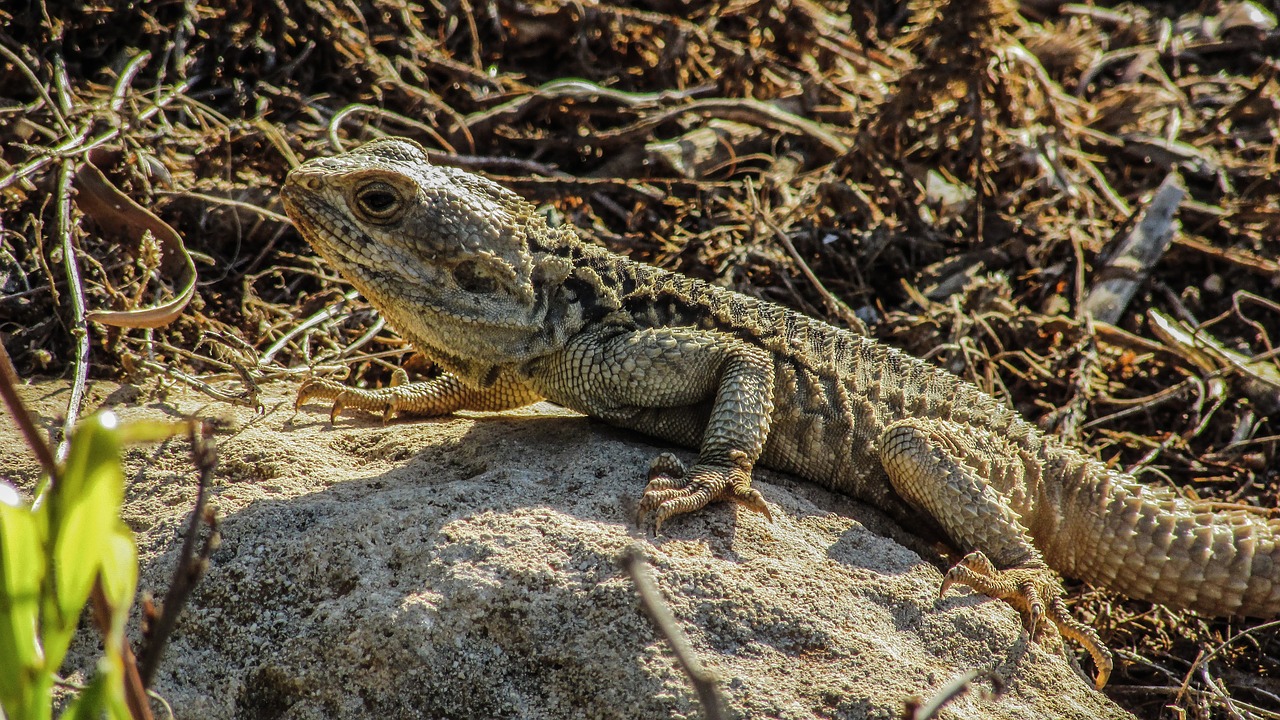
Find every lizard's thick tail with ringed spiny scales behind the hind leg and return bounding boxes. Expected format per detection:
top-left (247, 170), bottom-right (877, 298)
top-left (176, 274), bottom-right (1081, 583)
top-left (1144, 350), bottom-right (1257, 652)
top-left (1043, 460), bottom-right (1280, 618)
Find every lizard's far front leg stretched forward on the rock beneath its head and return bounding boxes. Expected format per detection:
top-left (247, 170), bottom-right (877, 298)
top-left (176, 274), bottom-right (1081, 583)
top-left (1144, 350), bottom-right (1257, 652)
top-left (293, 368), bottom-right (543, 423)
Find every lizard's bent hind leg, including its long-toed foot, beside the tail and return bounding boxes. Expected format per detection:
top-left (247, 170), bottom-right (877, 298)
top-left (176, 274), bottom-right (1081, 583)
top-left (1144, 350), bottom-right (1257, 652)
top-left (881, 419), bottom-right (1112, 688)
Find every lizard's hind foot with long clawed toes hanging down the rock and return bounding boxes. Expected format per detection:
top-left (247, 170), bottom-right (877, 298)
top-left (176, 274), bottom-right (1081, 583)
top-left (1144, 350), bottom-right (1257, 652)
top-left (938, 551), bottom-right (1112, 689)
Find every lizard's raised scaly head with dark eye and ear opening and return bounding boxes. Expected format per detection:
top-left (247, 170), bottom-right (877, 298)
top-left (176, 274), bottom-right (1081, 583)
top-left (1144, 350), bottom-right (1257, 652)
top-left (280, 138), bottom-right (567, 360)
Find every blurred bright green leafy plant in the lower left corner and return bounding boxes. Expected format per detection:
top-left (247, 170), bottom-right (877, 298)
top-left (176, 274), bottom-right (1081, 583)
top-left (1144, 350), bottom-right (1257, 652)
top-left (0, 413), bottom-right (191, 720)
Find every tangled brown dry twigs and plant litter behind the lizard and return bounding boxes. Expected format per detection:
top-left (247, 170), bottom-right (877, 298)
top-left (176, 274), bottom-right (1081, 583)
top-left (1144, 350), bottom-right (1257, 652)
top-left (0, 0), bottom-right (1280, 717)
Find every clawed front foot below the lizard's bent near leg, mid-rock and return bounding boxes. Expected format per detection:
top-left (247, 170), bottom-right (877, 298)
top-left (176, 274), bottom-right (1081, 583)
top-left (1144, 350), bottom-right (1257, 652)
top-left (636, 452), bottom-right (773, 533)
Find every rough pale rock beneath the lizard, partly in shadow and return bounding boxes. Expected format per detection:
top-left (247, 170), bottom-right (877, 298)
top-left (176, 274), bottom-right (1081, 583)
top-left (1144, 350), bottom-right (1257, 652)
top-left (0, 384), bottom-right (1130, 719)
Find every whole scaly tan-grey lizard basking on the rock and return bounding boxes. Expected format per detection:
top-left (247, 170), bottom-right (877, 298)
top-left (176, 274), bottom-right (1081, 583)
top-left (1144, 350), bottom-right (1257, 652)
top-left (280, 138), bottom-right (1280, 689)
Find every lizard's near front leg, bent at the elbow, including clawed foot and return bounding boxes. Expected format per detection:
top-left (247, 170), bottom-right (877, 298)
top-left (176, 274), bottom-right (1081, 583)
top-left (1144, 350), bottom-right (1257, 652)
top-left (535, 328), bottom-right (773, 530)
